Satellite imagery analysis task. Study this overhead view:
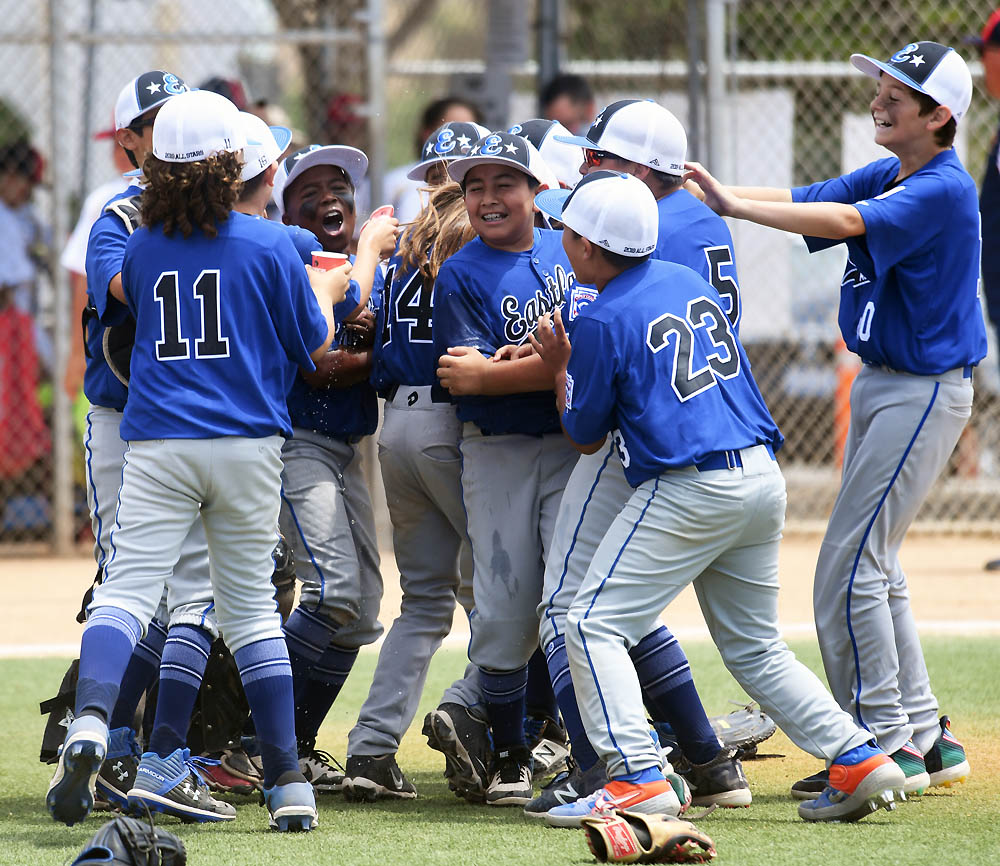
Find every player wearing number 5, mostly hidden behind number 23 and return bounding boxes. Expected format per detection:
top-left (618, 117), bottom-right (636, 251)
top-left (525, 99), bottom-right (752, 818)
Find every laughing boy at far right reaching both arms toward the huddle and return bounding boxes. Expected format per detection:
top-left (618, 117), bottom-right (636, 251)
top-left (691, 42), bottom-right (986, 798)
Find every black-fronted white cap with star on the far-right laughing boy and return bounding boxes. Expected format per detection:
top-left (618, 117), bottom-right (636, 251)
top-left (851, 42), bottom-right (972, 123)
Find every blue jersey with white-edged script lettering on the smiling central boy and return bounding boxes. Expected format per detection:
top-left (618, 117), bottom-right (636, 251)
top-left (434, 229), bottom-right (584, 435)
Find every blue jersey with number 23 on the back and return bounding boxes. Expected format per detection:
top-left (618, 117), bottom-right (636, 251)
top-left (562, 261), bottom-right (784, 487)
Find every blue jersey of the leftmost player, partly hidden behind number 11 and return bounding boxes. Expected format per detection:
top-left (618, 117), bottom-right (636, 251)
top-left (83, 185), bottom-right (142, 411)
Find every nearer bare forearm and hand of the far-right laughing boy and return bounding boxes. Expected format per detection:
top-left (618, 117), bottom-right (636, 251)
top-left (685, 162), bottom-right (865, 240)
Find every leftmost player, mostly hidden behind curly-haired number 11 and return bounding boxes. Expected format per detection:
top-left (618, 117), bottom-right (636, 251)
top-left (71, 70), bottom-right (227, 814)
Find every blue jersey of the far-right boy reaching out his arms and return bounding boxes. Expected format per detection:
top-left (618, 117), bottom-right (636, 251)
top-left (792, 150), bottom-right (986, 376)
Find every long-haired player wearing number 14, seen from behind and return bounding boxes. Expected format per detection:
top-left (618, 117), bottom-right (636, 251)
top-left (344, 122), bottom-right (489, 801)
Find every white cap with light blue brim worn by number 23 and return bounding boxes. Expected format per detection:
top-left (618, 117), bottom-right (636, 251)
top-left (535, 170), bottom-right (660, 258)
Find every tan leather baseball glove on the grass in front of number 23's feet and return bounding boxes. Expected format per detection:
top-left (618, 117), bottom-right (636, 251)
top-left (582, 809), bottom-right (715, 863)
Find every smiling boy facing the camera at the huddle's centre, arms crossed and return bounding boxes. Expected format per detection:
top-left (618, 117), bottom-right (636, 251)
top-left (433, 133), bottom-right (575, 805)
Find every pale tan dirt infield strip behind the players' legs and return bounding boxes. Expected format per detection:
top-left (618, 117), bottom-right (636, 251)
top-left (0, 535), bottom-right (1000, 656)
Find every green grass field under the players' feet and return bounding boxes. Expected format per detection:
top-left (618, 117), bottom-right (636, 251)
top-left (0, 638), bottom-right (1000, 866)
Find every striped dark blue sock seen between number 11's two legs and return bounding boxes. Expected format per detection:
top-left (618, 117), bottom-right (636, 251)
top-left (146, 625), bottom-right (212, 758)
